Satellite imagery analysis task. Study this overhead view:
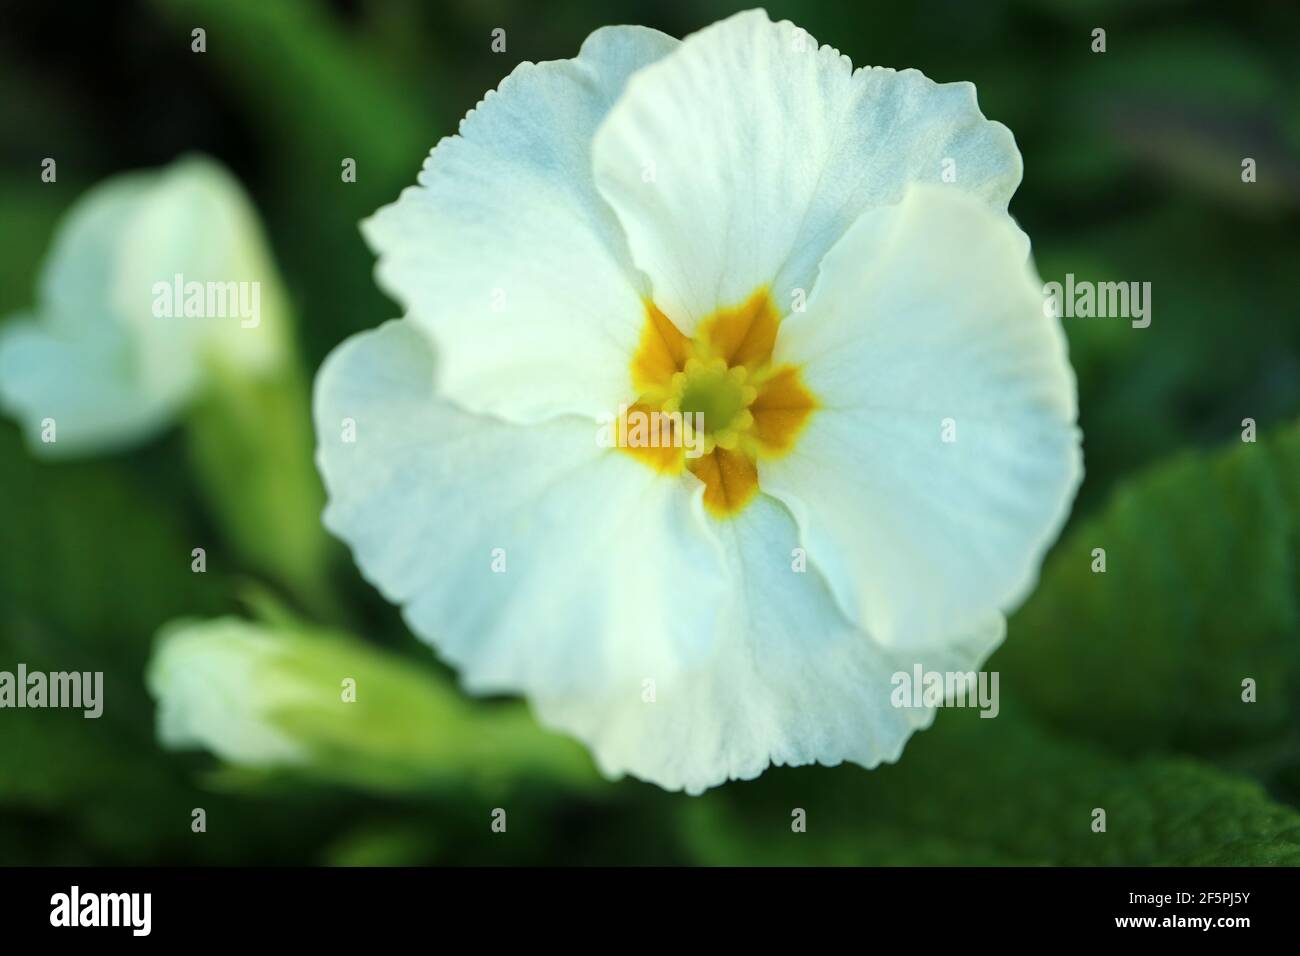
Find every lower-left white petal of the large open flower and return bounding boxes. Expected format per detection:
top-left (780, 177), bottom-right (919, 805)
top-left (315, 321), bottom-right (724, 696)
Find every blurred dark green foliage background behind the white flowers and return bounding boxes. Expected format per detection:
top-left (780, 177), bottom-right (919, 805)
top-left (0, 0), bottom-right (1300, 864)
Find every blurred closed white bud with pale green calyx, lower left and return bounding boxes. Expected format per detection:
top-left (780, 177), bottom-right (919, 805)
top-left (146, 615), bottom-right (595, 792)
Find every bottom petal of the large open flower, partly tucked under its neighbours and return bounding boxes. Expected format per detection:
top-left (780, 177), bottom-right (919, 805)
top-left (534, 496), bottom-right (1004, 793)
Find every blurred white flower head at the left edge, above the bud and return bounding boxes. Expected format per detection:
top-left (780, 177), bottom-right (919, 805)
top-left (0, 156), bottom-right (286, 458)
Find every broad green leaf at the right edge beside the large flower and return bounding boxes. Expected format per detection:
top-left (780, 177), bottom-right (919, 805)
top-left (992, 427), bottom-right (1300, 754)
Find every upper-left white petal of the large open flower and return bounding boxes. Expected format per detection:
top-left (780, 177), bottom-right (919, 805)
top-left (364, 27), bottom-right (676, 421)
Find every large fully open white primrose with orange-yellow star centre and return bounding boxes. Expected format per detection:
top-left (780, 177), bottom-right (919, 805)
top-left (315, 12), bottom-right (1080, 793)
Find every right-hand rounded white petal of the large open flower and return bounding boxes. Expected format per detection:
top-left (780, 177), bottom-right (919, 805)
top-left (759, 186), bottom-right (1082, 646)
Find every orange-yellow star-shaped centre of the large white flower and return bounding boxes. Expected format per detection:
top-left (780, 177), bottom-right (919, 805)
top-left (620, 287), bottom-right (816, 518)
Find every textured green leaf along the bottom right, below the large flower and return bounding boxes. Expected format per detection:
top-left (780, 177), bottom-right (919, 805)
top-left (681, 693), bottom-right (1300, 866)
